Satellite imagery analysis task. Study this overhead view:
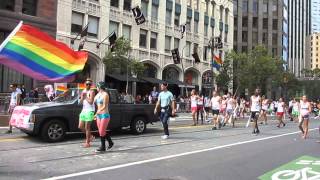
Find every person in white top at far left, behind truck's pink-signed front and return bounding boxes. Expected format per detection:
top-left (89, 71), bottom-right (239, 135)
top-left (6, 84), bottom-right (22, 134)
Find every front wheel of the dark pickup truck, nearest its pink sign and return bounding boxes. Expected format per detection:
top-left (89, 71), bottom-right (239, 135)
top-left (41, 119), bottom-right (67, 142)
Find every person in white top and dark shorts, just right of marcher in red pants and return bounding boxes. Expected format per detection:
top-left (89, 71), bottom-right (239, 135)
top-left (210, 91), bottom-right (221, 130)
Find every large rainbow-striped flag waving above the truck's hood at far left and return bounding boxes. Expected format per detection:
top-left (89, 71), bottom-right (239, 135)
top-left (0, 22), bottom-right (88, 82)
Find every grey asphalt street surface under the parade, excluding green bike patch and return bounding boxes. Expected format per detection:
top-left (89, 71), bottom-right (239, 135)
top-left (0, 116), bottom-right (320, 180)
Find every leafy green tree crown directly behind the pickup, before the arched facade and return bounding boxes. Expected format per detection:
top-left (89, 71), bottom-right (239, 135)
top-left (103, 37), bottom-right (145, 76)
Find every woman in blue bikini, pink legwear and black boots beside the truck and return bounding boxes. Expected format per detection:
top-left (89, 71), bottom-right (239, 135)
top-left (94, 82), bottom-right (114, 152)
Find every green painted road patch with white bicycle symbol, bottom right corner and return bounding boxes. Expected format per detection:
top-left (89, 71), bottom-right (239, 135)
top-left (259, 156), bottom-right (320, 180)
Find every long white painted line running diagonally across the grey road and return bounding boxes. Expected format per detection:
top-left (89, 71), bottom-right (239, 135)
top-left (43, 128), bottom-right (318, 180)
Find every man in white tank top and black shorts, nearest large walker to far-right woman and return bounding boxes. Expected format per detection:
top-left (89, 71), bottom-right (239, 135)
top-left (250, 89), bottom-right (261, 135)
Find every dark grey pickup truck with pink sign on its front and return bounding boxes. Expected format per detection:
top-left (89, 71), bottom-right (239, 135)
top-left (11, 89), bottom-right (158, 142)
